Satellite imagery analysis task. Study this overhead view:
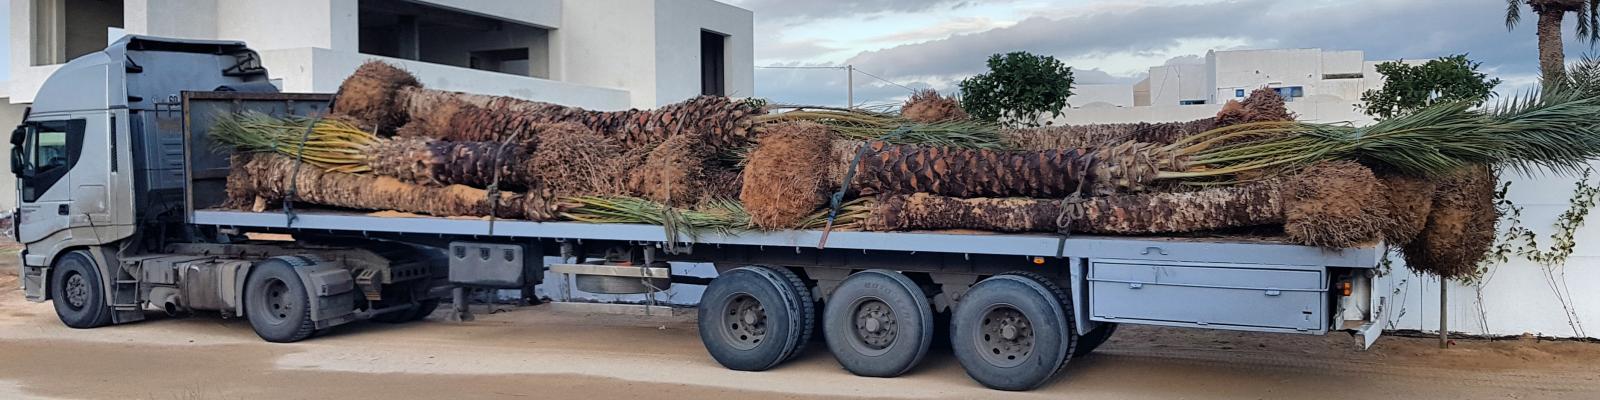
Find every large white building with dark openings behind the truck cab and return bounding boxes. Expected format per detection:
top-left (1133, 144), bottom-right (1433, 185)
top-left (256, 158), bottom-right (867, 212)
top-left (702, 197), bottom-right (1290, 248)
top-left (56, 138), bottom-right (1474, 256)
top-left (0, 0), bottom-right (755, 210)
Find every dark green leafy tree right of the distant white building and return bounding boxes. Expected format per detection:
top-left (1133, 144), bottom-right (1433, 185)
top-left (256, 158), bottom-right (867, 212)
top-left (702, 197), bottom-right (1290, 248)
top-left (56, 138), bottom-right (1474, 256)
top-left (1362, 54), bottom-right (1501, 120)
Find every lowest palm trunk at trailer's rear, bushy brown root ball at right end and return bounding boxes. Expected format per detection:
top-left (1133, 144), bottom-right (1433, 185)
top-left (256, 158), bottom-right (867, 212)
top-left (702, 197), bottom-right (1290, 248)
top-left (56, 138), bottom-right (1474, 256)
top-left (862, 162), bottom-right (1382, 248)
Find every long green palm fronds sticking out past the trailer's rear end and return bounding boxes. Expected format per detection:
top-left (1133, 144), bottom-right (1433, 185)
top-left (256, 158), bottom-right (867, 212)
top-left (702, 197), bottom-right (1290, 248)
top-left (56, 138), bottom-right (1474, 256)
top-left (1162, 86), bottom-right (1600, 179)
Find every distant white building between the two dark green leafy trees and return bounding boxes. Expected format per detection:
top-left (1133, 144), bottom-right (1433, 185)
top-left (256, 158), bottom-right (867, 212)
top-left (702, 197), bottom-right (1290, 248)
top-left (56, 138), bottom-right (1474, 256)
top-left (1056, 48), bottom-right (1384, 125)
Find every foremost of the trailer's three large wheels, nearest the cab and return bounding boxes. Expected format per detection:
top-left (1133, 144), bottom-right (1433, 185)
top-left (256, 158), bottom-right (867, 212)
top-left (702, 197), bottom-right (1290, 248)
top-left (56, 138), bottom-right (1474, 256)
top-left (698, 267), bottom-right (811, 371)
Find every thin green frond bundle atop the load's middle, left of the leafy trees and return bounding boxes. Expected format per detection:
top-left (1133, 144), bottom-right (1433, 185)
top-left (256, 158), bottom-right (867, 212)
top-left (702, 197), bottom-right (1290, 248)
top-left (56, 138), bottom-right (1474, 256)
top-left (755, 106), bottom-right (1003, 149)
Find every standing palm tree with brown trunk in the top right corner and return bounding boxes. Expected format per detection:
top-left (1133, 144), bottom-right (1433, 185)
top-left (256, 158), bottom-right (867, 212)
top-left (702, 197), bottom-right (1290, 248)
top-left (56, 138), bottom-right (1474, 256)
top-left (1506, 0), bottom-right (1600, 80)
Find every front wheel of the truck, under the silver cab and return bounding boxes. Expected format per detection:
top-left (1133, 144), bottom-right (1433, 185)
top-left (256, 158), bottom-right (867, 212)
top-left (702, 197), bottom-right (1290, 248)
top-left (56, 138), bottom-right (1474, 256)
top-left (50, 250), bottom-right (112, 330)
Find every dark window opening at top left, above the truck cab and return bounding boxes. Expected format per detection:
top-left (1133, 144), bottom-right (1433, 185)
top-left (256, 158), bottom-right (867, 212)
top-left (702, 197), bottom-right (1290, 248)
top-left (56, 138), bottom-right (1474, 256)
top-left (30, 0), bottom-right (122, 66)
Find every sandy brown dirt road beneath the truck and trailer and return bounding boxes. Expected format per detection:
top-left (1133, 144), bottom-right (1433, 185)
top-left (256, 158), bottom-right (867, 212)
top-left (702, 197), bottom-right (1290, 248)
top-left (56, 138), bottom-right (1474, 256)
top-left (0, 270), bottom-right (1600, 400)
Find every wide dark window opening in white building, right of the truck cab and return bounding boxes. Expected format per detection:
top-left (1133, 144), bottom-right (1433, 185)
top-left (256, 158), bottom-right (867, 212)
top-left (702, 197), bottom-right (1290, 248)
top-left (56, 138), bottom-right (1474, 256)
top-left (357, 0), bottom-right (550, 78)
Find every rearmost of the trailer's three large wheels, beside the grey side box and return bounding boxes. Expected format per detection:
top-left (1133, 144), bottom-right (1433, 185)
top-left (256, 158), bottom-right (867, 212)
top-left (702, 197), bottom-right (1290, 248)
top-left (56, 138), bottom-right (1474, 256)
top-left (950, 274), bottom-right (1077, 390)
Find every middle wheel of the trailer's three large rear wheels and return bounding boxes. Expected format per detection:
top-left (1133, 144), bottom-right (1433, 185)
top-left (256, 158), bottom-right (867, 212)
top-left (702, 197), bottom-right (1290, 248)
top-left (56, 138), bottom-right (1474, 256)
top-left (822, 269), bottom-right (933, 378)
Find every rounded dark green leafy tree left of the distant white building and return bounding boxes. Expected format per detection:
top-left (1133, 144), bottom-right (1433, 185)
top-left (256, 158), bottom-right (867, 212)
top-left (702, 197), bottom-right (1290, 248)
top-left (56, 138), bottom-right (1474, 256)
top-left (960, 51), bottom-right (1072, 126)
